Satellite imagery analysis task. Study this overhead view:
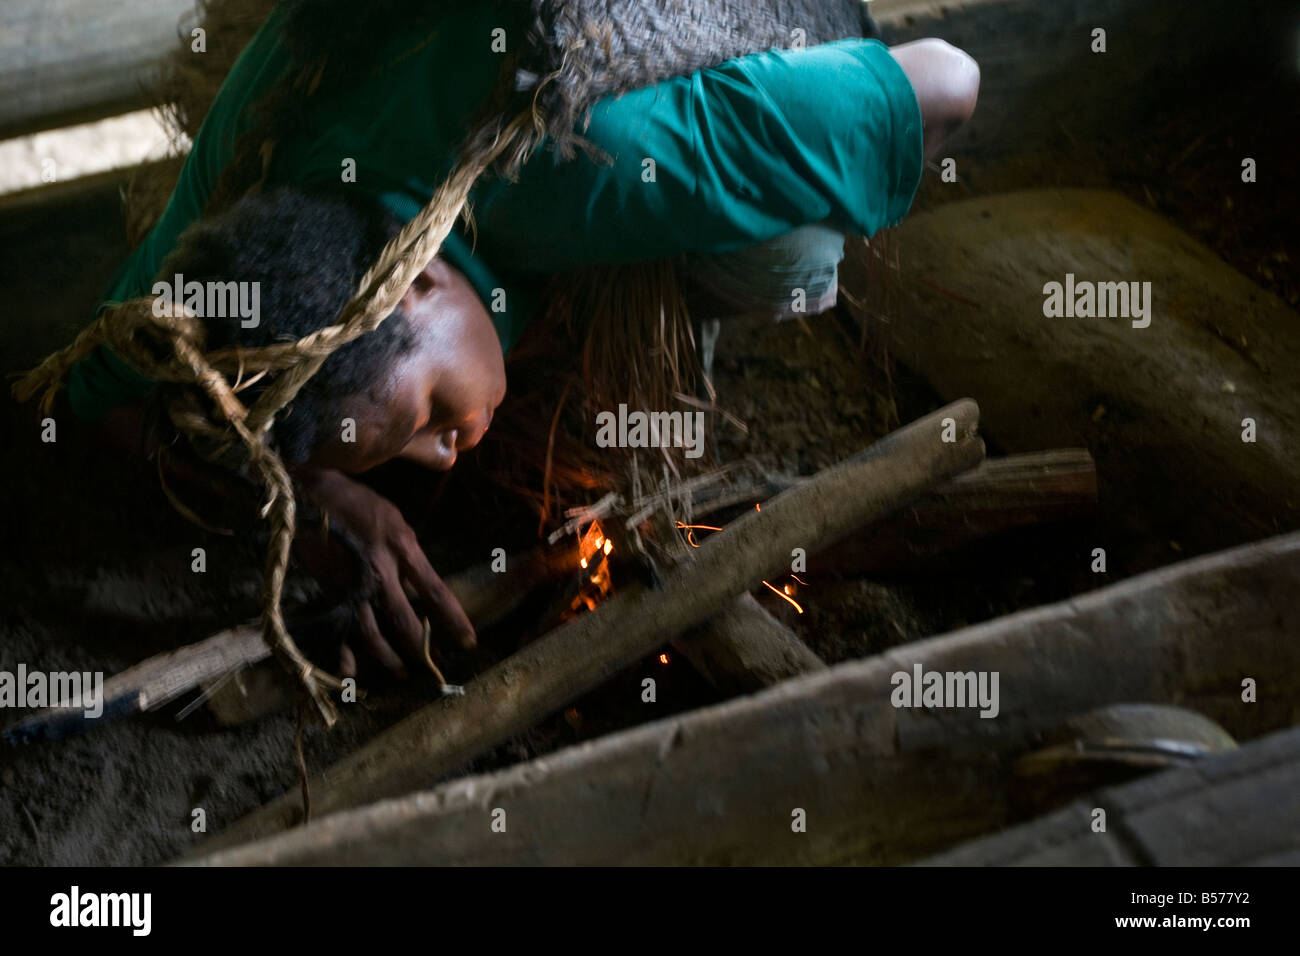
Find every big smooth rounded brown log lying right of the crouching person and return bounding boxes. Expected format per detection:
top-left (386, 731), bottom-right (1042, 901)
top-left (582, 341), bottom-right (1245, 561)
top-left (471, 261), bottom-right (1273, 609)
top-left (891, 190), bottom-right (1300, 574)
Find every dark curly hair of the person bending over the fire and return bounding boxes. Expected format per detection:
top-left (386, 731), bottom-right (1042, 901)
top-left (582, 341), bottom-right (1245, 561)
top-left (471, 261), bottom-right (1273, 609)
top-left (156, 186), bottom-right (416, 466)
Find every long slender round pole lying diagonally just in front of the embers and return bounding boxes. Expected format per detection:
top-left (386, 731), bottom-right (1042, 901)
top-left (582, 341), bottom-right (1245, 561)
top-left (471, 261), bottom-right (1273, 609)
top-left (192, 401), bottom-right (984, 845)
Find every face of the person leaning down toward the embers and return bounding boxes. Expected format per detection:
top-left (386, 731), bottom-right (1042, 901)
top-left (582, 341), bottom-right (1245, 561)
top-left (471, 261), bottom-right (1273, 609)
top-left (309, 258), bottom-right (506, 473)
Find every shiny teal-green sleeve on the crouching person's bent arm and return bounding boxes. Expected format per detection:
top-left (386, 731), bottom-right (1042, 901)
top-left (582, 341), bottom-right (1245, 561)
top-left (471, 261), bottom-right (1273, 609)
top-left (476, 39), bottom-right (923, 271)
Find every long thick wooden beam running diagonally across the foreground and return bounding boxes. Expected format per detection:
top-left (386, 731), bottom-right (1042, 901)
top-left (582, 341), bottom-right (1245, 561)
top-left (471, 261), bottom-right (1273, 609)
top-left (180, 533), bottom-right (1300, 865)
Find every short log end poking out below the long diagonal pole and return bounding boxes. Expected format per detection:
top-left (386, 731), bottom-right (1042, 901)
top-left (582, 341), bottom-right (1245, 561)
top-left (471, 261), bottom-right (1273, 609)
top-left (672, 593), bottom-right (826, 695)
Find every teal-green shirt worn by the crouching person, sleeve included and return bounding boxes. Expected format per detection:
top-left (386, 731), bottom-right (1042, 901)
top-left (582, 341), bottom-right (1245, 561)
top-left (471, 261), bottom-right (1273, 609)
top-left (69, 4), bottom-right (922, 420)
